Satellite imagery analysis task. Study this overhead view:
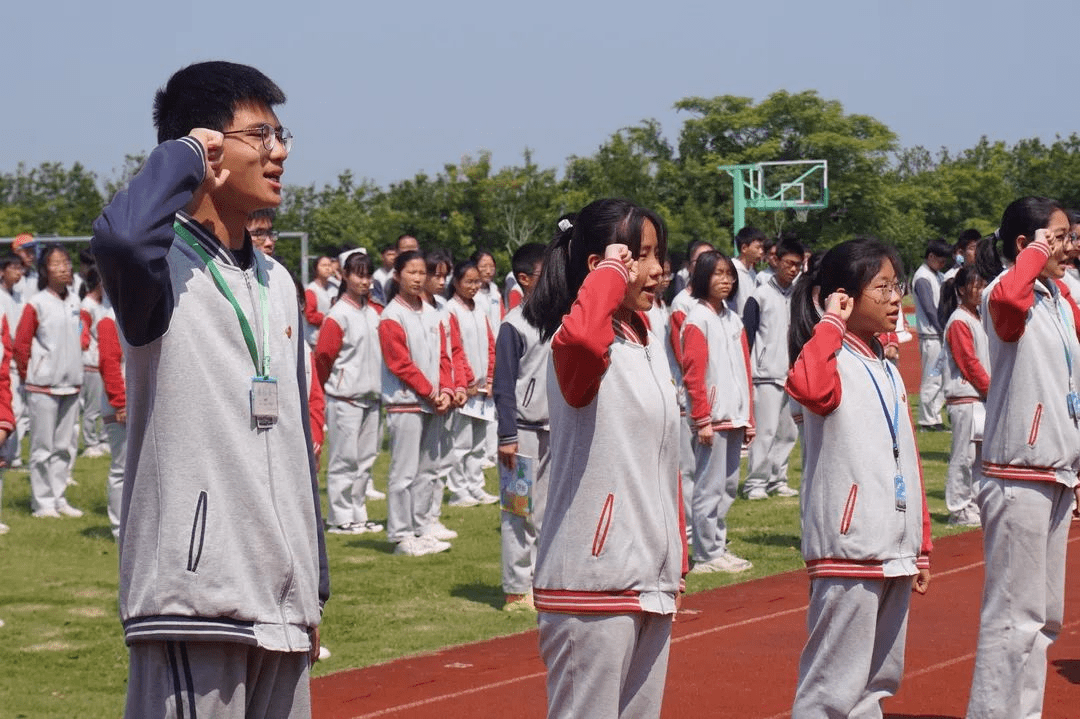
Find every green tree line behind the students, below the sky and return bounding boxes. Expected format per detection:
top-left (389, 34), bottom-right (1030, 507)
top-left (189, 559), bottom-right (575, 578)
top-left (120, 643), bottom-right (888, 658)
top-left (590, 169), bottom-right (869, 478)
top-left (0, 91), bottom-right (1080, 275)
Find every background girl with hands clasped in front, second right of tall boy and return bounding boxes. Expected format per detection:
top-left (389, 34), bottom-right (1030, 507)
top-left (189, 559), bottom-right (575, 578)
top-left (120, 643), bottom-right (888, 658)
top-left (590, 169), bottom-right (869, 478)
top-left (379, 249), bottom-right (454, 557)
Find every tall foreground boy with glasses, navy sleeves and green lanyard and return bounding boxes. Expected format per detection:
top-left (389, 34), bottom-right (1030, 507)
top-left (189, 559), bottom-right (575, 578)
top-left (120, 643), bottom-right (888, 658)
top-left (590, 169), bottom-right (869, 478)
top-left (93, 62), bottom-right (329, 719)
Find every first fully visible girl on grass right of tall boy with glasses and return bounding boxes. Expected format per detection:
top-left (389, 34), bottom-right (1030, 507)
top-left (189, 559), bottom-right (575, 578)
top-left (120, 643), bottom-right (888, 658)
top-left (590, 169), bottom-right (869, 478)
top-left (315, 252), bottom-right (382, 534)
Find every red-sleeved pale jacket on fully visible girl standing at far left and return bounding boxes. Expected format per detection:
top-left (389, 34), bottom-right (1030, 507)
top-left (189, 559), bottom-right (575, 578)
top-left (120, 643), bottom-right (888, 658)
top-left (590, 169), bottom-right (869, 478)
top-left (14, 289), bottom-right (82, 395)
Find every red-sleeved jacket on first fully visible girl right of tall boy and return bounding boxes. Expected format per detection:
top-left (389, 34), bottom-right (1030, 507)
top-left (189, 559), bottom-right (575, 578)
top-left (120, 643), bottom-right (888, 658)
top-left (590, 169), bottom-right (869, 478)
top-left (315, 295), bottom-right (382, 406)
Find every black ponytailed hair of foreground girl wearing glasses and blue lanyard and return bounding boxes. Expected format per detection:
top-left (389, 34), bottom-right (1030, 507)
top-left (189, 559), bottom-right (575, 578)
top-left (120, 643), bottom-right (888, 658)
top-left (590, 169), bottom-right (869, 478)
top-left (787, 238), bottom-right (904, 365)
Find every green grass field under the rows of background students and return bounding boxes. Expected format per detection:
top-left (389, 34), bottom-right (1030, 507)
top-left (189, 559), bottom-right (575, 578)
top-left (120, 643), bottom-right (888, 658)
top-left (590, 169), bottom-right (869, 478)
top-left (0, 425), bottom-right (955, 719)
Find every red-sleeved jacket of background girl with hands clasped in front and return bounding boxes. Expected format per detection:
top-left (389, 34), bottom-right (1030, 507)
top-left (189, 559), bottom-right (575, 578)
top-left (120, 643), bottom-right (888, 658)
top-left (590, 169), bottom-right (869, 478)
top-left (379, 295), bottom-right (453, 413)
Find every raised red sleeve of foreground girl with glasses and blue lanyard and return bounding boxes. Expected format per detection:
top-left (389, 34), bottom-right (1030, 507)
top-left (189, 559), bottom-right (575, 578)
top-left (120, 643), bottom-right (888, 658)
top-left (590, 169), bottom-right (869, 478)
top-left (785, 313), bottom-right (847, 417)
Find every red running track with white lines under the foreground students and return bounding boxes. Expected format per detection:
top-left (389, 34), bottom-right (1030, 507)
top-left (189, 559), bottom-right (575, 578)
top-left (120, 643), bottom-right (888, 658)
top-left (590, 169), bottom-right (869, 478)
top-left (312, 523), bottom-right (1080, 719)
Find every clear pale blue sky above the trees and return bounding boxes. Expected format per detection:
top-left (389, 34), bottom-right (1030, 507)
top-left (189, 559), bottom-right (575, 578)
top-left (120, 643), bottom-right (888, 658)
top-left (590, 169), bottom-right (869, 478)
top-left (0, 0), bottom-right (1080, 186)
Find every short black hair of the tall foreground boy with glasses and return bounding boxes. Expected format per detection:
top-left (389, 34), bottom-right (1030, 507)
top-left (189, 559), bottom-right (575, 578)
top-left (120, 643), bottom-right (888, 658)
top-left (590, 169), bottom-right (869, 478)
top-left (153, 60), bottom-right (285, 144)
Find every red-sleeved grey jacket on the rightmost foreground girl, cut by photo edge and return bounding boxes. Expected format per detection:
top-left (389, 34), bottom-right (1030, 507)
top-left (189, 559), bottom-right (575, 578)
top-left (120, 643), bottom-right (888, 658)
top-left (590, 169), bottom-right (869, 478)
top-left (982, 241), bottom-right (1080, 487)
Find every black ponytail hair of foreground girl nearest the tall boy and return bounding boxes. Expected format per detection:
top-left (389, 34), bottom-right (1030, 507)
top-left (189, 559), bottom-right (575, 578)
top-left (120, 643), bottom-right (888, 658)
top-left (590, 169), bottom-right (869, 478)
top-left (522, 199), bottom-right (667, 340)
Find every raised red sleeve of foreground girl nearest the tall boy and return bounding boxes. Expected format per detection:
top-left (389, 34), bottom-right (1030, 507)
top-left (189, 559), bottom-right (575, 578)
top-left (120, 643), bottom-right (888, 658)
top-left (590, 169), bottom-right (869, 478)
top-left (551, 260), bottom-right (630, 407)
